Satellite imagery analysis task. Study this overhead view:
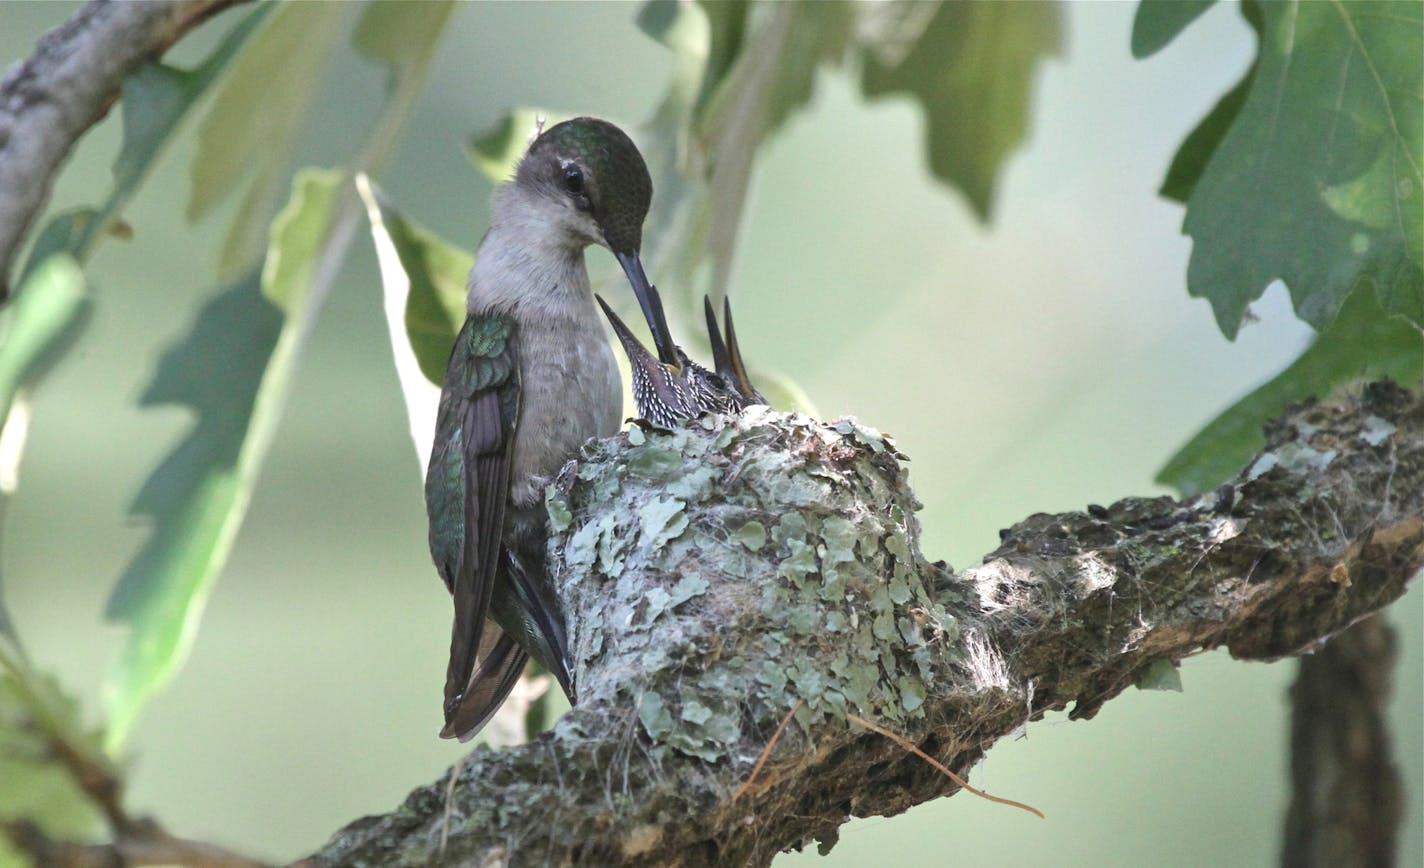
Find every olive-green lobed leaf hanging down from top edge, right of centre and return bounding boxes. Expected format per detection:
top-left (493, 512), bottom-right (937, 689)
top-left (860, 3), bottom-right (1062, 219)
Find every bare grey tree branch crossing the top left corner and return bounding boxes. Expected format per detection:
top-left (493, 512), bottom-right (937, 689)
top-left (0, 0), bottom-right (242, 302)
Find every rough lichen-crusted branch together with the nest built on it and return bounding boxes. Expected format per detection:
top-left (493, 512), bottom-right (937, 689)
top-left (308, 386), bottom-right (1424, 865)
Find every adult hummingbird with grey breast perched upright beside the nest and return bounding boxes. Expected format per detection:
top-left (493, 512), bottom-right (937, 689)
top-left (426, 117), bottom-right (672, 741)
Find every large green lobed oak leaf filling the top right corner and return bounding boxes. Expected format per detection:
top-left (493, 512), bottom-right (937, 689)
top-left (1163, 1), bottom-right (1424, 337)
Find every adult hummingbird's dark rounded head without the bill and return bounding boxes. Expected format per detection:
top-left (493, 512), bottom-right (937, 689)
top-left (514, 118), bottom-right (652, 253)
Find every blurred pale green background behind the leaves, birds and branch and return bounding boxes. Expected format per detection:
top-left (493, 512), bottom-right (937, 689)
top-left (0, 1), bottom-right (1424, 865)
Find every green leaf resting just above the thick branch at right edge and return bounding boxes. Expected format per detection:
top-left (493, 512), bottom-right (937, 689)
top-left (1158, 283), bottom-right (1424, 495)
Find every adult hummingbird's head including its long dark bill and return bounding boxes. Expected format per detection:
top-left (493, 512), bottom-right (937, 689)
top-left (514, 118), bottom-right (675, 361)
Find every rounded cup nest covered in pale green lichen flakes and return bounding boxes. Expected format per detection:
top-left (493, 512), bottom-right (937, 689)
top-left (545, 407), bottom-right (957, 763)
